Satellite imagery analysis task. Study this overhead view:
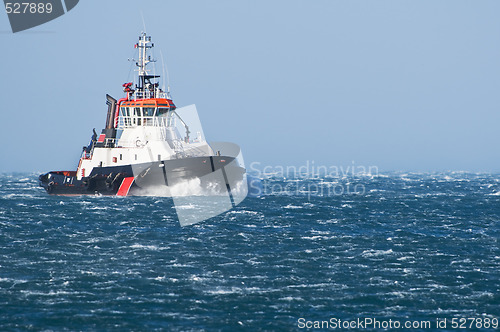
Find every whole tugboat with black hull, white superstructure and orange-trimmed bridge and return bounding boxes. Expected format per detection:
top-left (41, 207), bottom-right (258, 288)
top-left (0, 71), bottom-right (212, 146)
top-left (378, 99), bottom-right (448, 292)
top-left (39, 33), bottom-right (247, 200)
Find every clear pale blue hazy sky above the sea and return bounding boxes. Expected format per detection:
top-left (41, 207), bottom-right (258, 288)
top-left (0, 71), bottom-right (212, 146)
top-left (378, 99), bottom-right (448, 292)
top-left (0, 0), bottom-right (500, 172)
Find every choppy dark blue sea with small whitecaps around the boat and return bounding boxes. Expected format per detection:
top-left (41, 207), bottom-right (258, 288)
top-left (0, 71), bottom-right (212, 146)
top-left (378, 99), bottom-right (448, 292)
top-left (0, 173), bottom-right (500, 331)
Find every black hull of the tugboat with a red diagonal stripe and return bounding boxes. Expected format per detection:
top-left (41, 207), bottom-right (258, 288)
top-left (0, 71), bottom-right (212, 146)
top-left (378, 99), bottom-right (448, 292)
top-left (39, 156), bottom-right (245, 196)
